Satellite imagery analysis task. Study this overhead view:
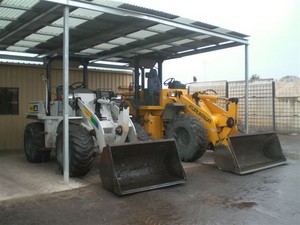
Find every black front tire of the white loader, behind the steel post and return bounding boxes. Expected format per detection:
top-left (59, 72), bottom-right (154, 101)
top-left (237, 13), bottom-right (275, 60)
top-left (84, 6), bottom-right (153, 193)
top-left (56, 123), bottom-right (95, 177)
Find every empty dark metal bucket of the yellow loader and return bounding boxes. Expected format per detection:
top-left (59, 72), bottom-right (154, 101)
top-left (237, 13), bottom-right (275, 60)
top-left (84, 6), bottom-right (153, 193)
top-left (214, 132), bottom-right (287, 174)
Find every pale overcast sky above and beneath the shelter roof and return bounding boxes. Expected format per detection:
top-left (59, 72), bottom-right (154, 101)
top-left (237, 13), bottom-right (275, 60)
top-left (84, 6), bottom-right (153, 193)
top-left (120, 0), bottom-right (300, 83)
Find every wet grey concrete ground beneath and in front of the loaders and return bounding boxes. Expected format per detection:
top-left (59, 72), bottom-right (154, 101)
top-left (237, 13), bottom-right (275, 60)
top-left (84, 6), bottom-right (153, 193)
top-left (0, 135), bottom-right (300, 225)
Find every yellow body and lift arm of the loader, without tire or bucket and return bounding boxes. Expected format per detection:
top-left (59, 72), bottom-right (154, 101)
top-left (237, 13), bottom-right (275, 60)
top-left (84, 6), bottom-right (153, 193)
top-left (128, 89), bottom-right (238, 146)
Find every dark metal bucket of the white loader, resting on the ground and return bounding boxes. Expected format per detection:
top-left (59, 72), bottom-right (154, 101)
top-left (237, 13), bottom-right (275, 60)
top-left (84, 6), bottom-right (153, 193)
top-left (100, 140), bottom-right (186, 195)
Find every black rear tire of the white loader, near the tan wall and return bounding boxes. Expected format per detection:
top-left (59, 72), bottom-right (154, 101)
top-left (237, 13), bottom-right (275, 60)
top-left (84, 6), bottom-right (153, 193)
top-left (24, 122), bottom-right (51, 163)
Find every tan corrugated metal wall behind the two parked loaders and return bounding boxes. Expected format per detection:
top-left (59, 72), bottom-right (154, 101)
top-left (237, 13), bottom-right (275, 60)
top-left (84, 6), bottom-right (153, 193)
top-left (0, 64), bottom-right (132, 150)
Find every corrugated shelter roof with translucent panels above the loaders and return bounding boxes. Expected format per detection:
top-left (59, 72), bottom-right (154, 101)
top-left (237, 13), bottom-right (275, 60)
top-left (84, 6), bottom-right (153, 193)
top-left (0, 0), bottom-right (248, 67)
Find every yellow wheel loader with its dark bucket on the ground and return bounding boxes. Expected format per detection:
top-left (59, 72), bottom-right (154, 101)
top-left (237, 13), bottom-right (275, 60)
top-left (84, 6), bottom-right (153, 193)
top-left (123, 69), bottom-right (286, 174)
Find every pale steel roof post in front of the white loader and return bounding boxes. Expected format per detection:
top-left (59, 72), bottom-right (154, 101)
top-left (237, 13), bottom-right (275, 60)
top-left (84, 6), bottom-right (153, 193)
top-left (63, 6), bottom-right (69, 184)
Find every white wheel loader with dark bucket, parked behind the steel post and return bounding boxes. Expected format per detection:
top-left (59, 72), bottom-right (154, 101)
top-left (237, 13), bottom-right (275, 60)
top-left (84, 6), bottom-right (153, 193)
top-left (24, 82), bottom-right (186, 195)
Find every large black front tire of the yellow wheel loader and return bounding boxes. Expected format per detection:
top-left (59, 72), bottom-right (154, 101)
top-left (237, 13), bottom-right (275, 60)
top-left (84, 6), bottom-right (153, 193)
top-left (166, 114), bottom-right (208, 162)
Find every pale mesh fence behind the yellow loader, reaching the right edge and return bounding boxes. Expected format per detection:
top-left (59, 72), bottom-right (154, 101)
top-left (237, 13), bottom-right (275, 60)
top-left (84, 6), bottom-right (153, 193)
top-left (189, 79), bottom-right (300, 133)
